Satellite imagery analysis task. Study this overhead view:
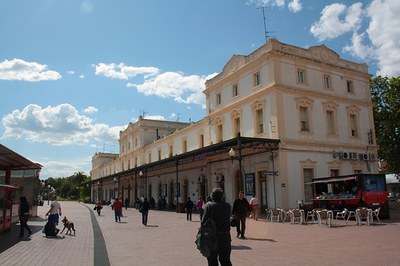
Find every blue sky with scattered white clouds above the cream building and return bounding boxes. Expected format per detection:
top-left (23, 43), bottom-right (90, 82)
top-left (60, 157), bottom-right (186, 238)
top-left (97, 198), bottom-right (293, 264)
top-left (0, 0), bottom-right (400, 179)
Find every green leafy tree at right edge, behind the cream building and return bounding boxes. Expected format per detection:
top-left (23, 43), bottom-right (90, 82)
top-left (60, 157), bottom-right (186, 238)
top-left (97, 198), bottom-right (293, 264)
top-left (371, 76), bottom-right (400, 175)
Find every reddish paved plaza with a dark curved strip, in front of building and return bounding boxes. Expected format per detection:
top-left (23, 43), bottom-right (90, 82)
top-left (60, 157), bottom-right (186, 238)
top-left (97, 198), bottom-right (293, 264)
top-left (0, 202), bottom-right (400, 266)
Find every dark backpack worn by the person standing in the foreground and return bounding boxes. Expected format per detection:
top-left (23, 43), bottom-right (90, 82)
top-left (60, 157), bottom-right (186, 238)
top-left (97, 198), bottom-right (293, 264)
top-left (195, 206), bottom-right (218, 257)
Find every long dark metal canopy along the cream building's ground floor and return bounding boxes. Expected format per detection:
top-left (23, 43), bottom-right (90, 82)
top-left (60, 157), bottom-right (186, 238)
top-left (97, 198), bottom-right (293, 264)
top-left (88, 135), bottom-right (280, 184)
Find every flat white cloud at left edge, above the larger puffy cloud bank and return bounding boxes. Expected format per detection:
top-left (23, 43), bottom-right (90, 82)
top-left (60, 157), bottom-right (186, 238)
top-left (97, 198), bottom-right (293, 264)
top-left (0, 58), bottom-right (61, 82)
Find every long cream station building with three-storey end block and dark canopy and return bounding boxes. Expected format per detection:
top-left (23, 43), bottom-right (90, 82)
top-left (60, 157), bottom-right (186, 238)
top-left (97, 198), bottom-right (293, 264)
top-left (92, 39), bottom-right (378, 209)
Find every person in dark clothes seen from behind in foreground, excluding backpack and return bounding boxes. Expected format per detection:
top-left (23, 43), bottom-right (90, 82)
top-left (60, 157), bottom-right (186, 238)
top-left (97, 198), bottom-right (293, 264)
top-left (201, 188), bottom-right (232, 266)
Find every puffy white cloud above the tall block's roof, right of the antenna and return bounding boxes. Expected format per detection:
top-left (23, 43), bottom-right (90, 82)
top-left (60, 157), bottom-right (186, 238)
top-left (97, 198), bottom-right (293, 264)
top-left (310, 3), bottom-right (363, 41)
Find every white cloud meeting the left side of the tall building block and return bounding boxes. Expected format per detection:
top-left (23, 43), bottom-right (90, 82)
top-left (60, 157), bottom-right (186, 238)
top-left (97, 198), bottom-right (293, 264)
top-left (127, 72), bottom-right (216, 106)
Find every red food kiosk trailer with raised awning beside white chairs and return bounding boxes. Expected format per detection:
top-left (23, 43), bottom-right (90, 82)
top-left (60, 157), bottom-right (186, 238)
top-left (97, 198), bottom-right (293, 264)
top-left (312, 174), bottom-right (389, 218)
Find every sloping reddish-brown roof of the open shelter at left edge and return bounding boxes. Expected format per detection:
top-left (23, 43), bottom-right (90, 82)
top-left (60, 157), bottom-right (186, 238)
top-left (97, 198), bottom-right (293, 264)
top-left (0, 144), bottom-right (42, 171)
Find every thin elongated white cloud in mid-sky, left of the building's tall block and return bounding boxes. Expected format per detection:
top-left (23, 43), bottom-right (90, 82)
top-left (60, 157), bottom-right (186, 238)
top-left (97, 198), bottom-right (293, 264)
top-left (94, 63), bottom-right (159, 80)
